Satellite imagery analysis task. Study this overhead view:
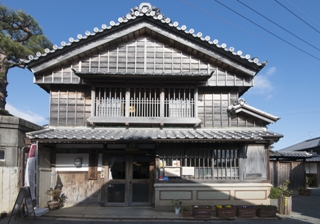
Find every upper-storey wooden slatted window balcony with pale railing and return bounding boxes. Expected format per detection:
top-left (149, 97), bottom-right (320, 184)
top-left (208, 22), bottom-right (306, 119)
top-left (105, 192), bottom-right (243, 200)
top-left (88, 87), bottom-right (201, 124)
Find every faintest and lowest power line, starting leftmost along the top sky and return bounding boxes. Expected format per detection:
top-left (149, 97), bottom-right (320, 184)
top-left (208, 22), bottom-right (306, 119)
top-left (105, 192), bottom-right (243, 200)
top-left (180, 0), bottom-right (320, 67)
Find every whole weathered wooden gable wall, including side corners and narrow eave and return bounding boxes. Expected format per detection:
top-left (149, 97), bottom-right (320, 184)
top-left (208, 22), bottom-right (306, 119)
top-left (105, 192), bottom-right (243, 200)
top-left (35, 35), bottom-right (253, 89)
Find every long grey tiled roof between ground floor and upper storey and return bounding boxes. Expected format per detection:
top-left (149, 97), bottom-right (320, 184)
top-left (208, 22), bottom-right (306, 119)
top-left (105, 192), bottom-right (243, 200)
top-left (26, 128), bottom-right (283, 141)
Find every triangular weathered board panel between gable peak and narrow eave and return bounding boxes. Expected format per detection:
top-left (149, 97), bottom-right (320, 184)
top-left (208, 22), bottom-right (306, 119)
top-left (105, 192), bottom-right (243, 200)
top-left (78, 36), bottom-right (211, 75)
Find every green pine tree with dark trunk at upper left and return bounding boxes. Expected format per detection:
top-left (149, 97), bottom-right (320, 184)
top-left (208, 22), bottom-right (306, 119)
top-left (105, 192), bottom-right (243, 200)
top-left (0, 3), bottom-right (52, 114)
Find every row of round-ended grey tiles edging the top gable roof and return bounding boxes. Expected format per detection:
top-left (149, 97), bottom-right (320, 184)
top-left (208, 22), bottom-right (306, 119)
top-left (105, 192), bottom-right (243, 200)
top-left (25, 3), bottom-right (266, 66)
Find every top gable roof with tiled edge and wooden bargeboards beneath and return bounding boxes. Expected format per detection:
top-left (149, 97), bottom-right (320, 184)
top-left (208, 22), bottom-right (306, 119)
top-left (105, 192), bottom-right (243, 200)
top-left (27, 4), bottom-right (266, 77)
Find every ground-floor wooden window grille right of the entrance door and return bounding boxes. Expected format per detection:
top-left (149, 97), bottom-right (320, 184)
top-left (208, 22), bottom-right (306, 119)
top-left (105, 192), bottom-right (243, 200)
top-left (159, 149), bottom-right (239, 180)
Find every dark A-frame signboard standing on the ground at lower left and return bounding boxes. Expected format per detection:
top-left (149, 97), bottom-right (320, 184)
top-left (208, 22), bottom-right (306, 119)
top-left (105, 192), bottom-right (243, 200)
top-left (8, 187), bottom-right (36, 223)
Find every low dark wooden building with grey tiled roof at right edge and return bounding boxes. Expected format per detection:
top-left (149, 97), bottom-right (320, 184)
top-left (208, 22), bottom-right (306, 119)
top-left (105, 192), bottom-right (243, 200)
top-left (270, 137), bottom-right (320, 189)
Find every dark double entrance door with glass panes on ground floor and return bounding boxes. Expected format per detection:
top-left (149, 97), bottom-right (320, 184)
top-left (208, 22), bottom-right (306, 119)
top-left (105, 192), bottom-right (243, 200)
top-left (107, 153), bottom-right (153, 206)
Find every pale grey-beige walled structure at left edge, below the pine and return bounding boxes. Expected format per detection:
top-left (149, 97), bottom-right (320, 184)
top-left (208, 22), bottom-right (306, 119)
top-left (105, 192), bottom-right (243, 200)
top-left (0, 115), bottom-right (42, 213)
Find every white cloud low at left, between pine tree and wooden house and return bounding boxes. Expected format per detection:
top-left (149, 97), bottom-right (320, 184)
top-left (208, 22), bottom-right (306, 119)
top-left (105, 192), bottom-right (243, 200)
top-left (6, 103), bottom-right (48, 125)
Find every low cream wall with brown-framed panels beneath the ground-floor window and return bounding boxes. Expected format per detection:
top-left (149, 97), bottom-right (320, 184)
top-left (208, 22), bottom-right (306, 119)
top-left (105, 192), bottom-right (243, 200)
top-left (155, 183), bottom-right (272, 211)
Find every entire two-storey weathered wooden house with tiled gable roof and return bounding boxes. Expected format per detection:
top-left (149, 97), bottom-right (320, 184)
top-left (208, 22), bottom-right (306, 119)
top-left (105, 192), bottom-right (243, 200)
top-left (26, 3), bottom-right (283, 210)
